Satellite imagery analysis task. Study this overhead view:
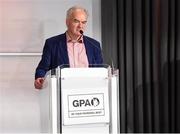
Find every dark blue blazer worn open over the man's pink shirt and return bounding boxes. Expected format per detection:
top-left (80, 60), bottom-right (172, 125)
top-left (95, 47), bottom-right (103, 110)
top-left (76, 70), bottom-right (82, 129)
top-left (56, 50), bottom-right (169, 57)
top-left (35, 33), bottom-right (103, 79)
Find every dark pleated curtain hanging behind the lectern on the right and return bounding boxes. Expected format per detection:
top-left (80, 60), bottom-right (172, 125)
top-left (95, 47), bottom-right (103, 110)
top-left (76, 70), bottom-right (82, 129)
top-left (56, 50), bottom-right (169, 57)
top-left (101, 0), bottom-right (180, 132)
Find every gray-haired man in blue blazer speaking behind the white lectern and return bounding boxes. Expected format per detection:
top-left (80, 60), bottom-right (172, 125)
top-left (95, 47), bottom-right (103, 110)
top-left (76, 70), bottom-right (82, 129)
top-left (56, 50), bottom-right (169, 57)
top-left (34, 6), bottom-right (103, 89)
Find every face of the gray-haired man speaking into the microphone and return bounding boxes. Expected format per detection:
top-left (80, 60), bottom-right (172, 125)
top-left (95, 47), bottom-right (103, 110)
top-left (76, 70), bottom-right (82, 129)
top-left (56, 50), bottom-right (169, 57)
top-left (66, 10), bottom-right (87, 37)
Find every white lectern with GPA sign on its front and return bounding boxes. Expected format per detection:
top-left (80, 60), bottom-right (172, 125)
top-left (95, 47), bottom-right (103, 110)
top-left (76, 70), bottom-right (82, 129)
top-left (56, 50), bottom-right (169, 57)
top-left (41, 67), bottom-right (120, 134)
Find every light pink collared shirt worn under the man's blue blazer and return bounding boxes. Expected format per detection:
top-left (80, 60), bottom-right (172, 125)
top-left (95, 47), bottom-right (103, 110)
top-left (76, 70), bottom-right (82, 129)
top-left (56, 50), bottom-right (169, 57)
top-left (66, 33), bottom-right (89, 68)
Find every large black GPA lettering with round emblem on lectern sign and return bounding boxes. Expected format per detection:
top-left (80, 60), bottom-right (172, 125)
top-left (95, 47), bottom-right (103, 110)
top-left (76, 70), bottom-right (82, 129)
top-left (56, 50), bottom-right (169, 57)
top-left (72, 97), bottom-right (100, 107)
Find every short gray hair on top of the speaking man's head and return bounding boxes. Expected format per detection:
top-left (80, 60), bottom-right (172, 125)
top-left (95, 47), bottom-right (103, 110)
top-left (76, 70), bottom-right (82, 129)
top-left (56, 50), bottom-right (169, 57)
top-left (66, 6), bottom-right (89, 19)
